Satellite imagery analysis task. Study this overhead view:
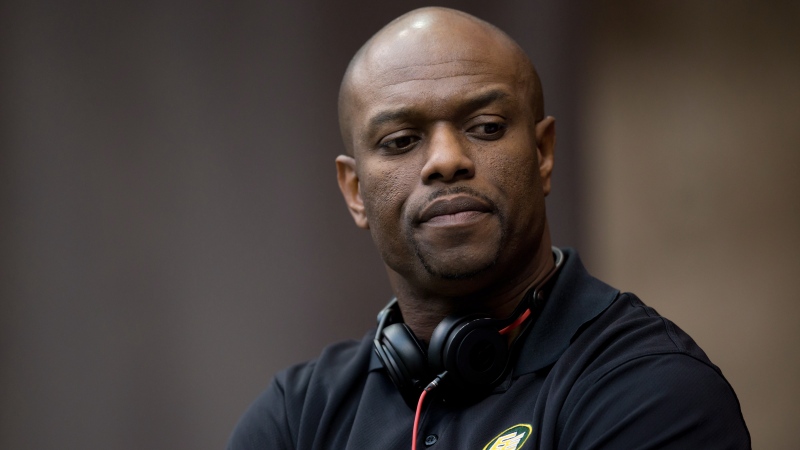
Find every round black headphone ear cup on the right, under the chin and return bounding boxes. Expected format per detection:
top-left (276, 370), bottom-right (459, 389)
top-left (428, 316), bottom-right (510, 390)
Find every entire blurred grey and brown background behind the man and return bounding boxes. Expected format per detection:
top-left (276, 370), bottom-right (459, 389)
top-left (0, 0), bottom-right (800, 449)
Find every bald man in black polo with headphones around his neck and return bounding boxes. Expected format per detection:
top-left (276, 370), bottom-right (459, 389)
top-left (230, 8), bottom-right (750, 449)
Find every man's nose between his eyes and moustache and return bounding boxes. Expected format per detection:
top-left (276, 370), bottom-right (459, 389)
top-left (422, 125), bottom-right (475, 183)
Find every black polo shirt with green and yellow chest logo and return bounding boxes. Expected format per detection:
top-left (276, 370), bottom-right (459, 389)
top-left (228, 250), bottom-right (750, 450)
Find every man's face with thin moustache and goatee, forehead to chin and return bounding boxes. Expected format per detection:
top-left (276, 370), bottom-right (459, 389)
top-left (339, 25), bottom-right (552, 298)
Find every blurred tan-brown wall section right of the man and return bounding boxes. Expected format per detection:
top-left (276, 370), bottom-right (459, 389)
top-left (580, 2), bottom-right (800, 449)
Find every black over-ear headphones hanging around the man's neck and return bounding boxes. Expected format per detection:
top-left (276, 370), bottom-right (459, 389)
top-left (373, 247), bottom-right (564, 409)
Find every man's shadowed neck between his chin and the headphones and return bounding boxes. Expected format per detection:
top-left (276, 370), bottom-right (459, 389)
top-left (389, 240), bottom-right (555, 342)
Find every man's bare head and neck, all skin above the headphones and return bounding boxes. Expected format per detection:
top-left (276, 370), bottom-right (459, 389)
top-left (336, 8), bottom-right (555, 341)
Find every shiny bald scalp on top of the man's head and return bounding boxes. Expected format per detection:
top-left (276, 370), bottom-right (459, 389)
top-left (339, 7), bottom-right (544, 155)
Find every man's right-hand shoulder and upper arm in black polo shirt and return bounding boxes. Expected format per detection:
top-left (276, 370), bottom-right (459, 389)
top-left (554, 294), bottom-right (750, 449)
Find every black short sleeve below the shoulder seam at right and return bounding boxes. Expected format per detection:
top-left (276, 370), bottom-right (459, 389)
top-left (558, 353), bottom-right (750, 450)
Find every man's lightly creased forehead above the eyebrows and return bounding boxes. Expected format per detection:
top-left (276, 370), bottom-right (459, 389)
top-left (349, 29), bottom-right (529, 123)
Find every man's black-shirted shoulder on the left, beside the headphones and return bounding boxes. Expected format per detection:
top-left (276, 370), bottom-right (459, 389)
top-left (228, 335), bottom-right (371, 450)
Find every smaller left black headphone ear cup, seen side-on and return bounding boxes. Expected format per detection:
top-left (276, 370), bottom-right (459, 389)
top-left (375, 323), bottom-right (430, 395)
